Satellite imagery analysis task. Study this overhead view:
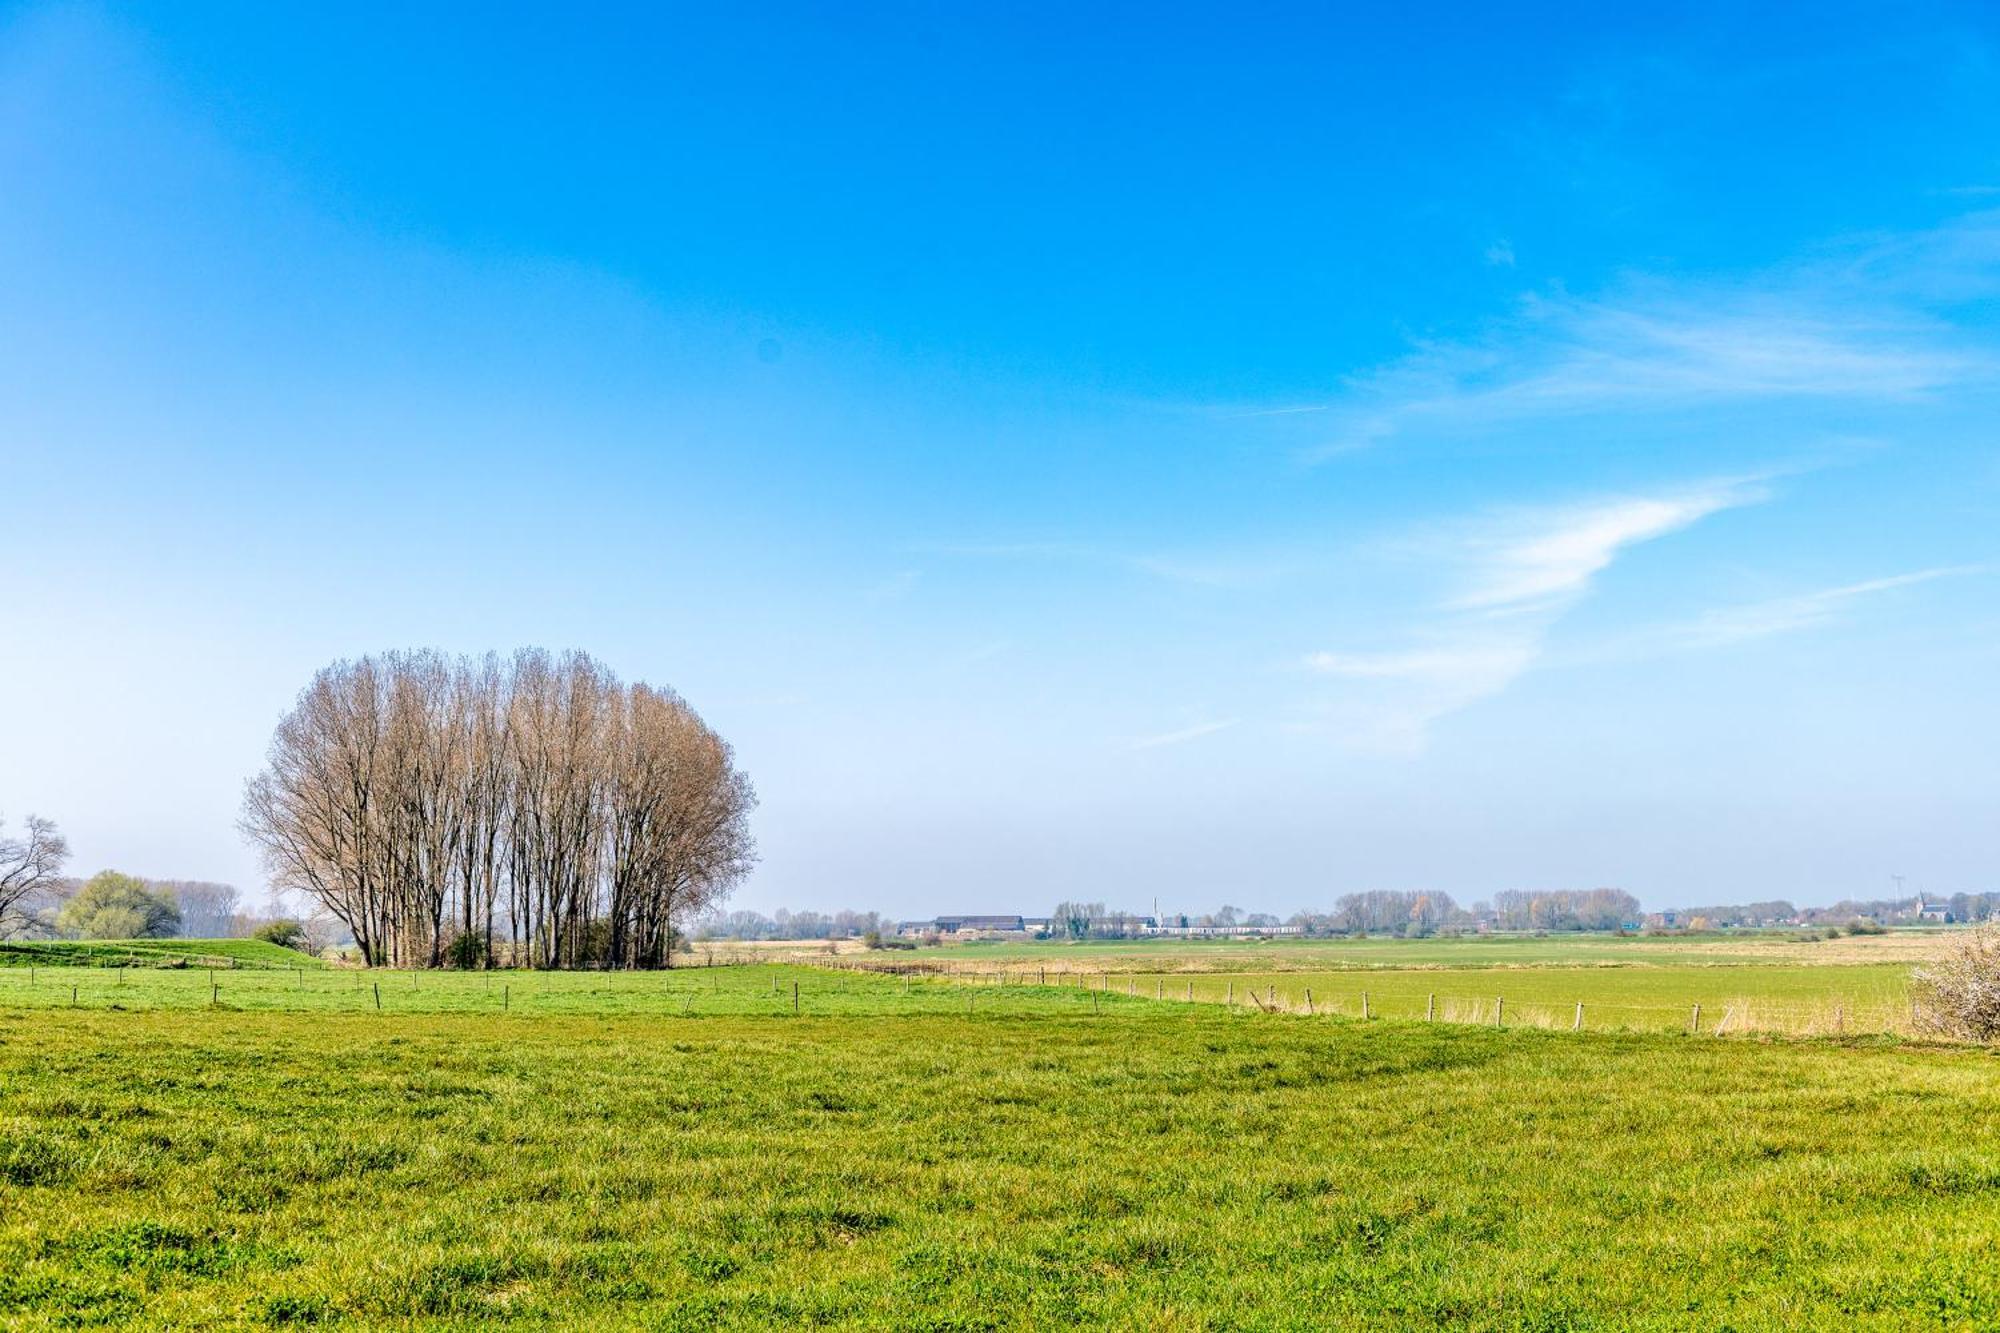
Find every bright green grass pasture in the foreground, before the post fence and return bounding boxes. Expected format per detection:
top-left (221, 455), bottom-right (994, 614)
top-left (0, 969), bottom-right (2000, 1329)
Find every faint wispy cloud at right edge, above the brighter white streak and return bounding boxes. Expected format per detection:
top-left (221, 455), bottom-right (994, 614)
top-left (1224, 212), bottom-right (2000, 462)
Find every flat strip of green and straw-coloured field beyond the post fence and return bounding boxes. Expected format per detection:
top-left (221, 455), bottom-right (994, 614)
top-left (0, 951), bottom-right (1912, 1037)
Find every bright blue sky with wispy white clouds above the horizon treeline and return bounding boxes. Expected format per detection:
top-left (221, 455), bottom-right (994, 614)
top-left (0, 4), bottom-right (2000, 913)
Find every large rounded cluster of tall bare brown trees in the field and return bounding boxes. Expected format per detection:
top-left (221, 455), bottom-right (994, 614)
top-left (242, 648), bottom-right (756, 967)
